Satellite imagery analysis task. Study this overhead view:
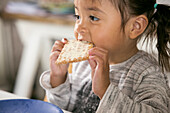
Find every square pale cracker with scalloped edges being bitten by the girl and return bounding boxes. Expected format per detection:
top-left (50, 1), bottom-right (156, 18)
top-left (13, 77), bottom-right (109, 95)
top-left (56, 40), bottom-right (93, 64)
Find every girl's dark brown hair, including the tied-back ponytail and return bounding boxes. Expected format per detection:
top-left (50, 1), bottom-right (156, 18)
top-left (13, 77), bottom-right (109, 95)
top-left (110, 0), bottom-right (170, 71)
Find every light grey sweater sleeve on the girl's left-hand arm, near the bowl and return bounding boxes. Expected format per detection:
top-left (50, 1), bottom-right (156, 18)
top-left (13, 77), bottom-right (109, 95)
top-left (40, 71), bottom-right (71, 109)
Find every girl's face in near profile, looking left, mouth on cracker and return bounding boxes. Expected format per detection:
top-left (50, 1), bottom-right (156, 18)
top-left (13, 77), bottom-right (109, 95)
top-left (74, 0), bottom-right (137, 62)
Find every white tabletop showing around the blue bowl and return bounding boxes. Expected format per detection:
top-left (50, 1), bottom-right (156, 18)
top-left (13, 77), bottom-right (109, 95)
top-left (0, 90), bottom-right (71, 113)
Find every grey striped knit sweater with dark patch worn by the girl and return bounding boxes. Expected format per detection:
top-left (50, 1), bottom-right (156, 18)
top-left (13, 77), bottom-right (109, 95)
top-left (40, 51), bottom-right (170, 113)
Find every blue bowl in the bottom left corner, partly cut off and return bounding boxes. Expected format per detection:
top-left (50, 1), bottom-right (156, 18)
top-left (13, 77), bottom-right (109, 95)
top-left (0, 99), bottom-right (63, 113)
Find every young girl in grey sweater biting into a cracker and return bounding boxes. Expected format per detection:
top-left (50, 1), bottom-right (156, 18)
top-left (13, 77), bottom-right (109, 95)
top-left (40, 0), bottom-right (170, 113)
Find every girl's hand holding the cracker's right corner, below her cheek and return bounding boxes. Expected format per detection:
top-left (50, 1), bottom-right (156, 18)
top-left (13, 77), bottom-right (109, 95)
top-left (89, 47), bottom-right (110, 99)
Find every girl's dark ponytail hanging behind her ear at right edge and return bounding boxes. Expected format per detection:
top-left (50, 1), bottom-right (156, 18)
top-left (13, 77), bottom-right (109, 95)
top-left (147, 4), bottom-right (170, 71)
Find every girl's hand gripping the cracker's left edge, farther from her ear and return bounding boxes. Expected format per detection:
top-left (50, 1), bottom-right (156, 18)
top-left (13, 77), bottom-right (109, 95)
top-left (50, 39), bottom-right (68, 87)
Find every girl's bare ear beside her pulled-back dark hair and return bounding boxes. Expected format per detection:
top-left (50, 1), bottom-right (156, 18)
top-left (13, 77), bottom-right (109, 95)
top-left (130, 15), bottom-right (148, 39)
